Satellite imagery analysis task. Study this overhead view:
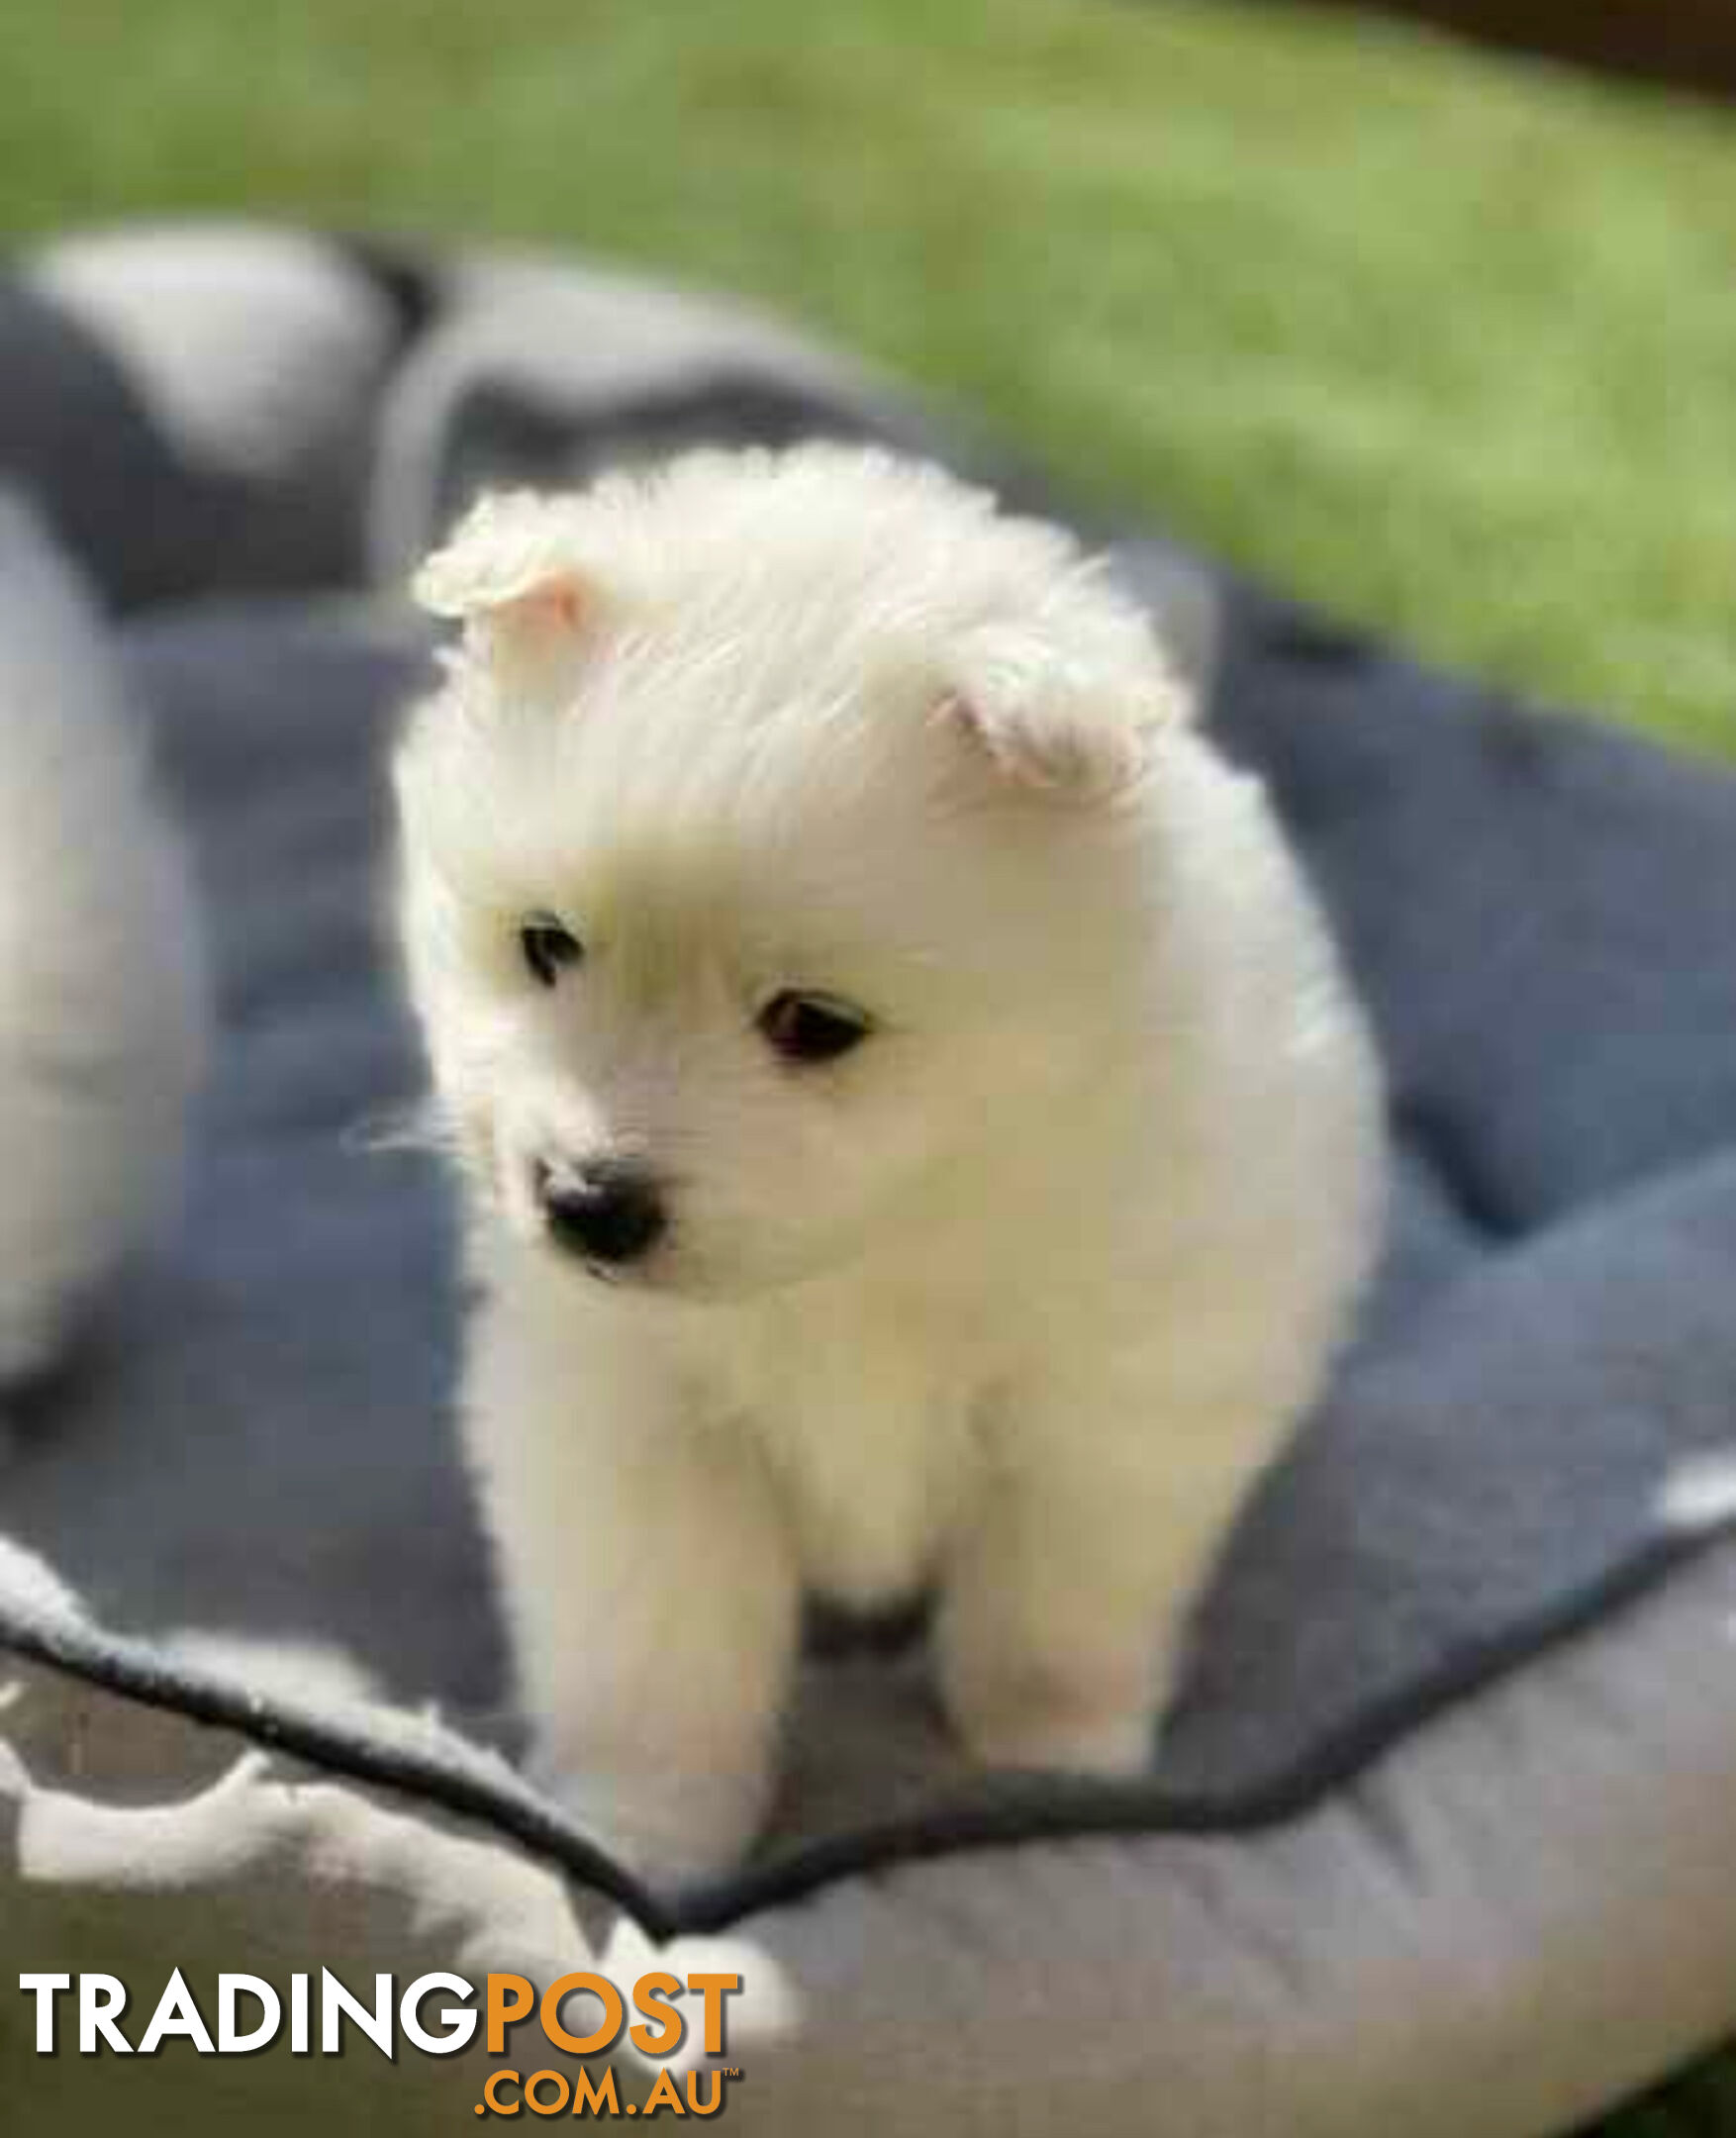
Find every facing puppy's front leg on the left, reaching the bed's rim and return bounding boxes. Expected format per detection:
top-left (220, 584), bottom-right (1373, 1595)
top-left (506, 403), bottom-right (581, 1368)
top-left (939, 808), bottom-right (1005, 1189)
top-left (468, 1300), bottom-right (798, 1886)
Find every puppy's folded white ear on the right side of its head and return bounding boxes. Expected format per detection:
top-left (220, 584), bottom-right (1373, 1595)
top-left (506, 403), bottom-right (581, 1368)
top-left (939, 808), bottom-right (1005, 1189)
top-left (934, 627), bottom-right (1191, 802)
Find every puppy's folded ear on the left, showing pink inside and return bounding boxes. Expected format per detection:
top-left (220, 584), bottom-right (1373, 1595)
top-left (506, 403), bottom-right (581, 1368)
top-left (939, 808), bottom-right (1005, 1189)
top-left (411, 490), bottom-right (603, 689)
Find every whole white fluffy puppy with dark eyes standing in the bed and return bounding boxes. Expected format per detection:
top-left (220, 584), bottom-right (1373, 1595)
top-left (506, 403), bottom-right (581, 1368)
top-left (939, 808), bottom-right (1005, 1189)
top-left (398, 446), bottom-right (1381, 1880)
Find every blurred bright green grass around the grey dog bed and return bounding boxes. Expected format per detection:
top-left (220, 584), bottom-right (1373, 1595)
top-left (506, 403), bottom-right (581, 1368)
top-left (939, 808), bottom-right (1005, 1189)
top-left (0, 0), bottom-right (1736, 2138)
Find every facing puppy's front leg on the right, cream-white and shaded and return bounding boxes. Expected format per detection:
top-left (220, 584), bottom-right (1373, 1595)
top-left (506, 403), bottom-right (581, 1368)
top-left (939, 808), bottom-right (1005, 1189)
top-left (936, 1409), bottom-right (1281, 1775)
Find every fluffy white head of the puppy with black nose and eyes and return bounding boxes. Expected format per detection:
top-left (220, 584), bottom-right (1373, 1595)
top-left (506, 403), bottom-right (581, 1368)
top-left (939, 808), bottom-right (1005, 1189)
top-left (398, 446), bottom-right (1178, 1298)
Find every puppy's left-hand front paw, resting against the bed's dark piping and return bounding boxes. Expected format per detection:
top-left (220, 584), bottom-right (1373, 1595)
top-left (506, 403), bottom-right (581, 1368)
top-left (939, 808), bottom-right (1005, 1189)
top-left (534, 1768), bottom-right (763, 1893)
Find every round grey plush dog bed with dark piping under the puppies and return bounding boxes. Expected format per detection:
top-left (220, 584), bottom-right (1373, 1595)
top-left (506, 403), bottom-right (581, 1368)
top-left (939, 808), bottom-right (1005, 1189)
top-left (0, 229), bottom-right (1736, 2138)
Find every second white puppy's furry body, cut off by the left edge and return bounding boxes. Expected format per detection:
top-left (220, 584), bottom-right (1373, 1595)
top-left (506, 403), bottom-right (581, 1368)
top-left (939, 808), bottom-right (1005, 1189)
top-left (0, 500), bottom-right (205, 1388)
